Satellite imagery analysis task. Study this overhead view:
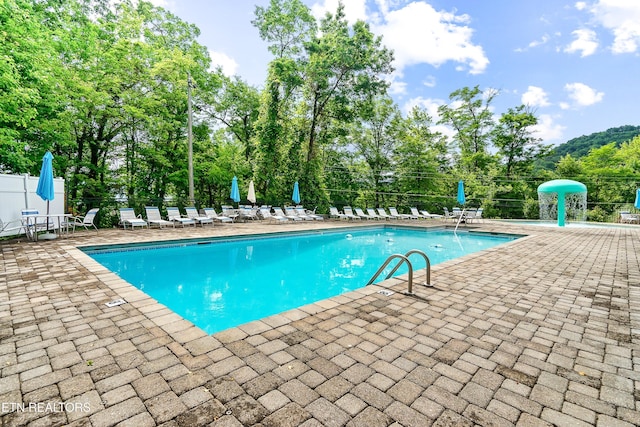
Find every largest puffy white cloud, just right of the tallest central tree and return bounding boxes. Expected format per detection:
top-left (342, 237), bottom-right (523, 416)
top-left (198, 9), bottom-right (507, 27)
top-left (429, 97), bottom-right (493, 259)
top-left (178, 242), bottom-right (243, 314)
top-left (370, 0), bottom-right (489, 75)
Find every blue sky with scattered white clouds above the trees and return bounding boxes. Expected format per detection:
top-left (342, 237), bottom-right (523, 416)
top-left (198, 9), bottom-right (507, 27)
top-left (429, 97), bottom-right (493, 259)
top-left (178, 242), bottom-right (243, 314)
top-left (152, 0), bottom-right (640, 144)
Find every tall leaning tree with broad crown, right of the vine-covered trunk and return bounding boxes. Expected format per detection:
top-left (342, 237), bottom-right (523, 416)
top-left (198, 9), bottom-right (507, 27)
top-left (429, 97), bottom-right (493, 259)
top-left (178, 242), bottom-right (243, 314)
top-left (300, 4), bottom-right (393, 209)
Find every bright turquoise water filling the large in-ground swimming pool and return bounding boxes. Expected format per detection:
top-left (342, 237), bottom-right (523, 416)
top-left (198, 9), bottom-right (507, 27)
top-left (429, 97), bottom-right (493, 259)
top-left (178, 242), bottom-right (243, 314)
top-left (84, 226), bottom-right (518, 333)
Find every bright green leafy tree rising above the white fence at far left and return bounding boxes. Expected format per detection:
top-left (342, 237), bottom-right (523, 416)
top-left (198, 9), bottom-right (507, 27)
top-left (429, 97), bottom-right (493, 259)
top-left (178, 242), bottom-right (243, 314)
top-left (0, 0), bottom-right (68, 174)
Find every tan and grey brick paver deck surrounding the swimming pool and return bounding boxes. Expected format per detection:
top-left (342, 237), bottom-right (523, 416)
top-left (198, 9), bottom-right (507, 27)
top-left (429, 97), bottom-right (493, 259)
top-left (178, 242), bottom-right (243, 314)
top-left (0, 221), bottom-right (640, 427)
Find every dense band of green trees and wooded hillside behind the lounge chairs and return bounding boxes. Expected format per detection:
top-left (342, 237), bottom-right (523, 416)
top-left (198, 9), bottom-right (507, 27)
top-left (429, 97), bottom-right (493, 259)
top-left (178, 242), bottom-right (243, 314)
top-left (0, 0), bottom-right (640, 225)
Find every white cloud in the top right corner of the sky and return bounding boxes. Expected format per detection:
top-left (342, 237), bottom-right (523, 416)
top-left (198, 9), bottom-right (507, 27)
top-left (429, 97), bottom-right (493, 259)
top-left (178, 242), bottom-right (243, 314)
top-left (590, 0), bottom-right (640, 53)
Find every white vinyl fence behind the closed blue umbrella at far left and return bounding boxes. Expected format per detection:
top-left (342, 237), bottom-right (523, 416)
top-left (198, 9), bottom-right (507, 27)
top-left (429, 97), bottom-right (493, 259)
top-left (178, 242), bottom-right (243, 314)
top-left (0, 174), bottom-right (65, 237)
